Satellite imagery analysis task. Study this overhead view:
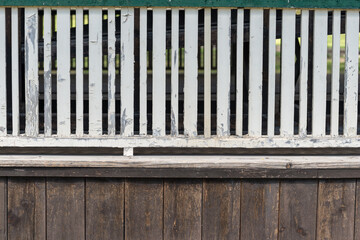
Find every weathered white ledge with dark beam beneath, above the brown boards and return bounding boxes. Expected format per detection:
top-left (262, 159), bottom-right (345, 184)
top-left (0, 155), bottom-right (360, 179)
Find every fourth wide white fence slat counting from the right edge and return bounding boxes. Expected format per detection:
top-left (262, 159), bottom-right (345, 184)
top-left (249, 9), bottom-right (264, 137)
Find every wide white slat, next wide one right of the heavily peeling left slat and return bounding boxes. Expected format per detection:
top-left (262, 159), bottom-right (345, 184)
top-left (57, 8), bottom-right (70, 137)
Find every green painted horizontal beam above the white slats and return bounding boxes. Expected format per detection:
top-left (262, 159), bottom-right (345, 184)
top-left (0, 0), bottom-right (360, 9)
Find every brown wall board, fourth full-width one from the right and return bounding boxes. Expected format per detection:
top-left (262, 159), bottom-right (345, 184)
top-left (202, 180), bottom-right (241, 239)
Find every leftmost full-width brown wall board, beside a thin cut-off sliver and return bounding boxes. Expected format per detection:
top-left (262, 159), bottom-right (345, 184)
top-left (8, 178), bottom-right (46, 240)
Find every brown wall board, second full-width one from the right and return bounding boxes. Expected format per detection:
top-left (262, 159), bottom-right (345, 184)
top-left (279, 180), bottom-right (318, 240)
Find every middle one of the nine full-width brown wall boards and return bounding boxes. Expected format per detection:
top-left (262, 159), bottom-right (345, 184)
top-left (164, 179), bottom-right (202, 239)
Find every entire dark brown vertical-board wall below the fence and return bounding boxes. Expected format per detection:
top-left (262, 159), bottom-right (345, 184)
top-left (0, 178), bottom-right (360, 240)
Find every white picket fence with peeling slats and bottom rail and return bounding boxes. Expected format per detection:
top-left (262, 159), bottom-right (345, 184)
top-left (0, 7), bottom-right (360, 154)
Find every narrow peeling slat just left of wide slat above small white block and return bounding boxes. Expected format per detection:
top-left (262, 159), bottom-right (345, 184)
top-left (108, 8), bottom-right (116, 136)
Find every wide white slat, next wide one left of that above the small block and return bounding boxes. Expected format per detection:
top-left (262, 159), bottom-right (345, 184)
top-left (89, 8), bottom-right (103, 136)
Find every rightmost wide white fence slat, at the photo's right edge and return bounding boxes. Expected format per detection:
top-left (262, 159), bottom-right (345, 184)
top-left (344, 10), bottom-right (359, 137)
